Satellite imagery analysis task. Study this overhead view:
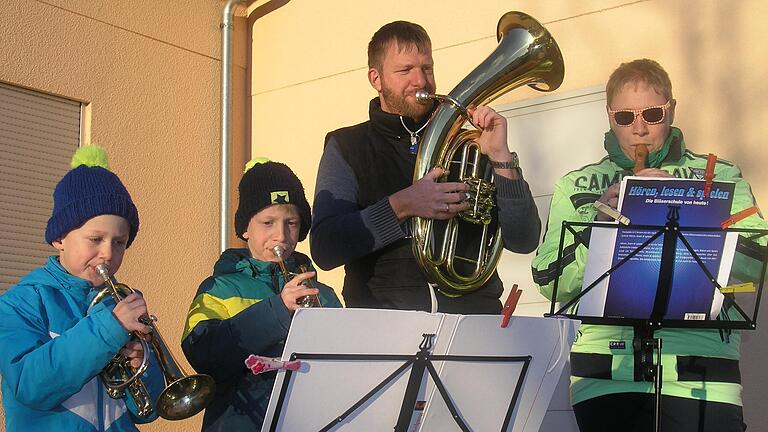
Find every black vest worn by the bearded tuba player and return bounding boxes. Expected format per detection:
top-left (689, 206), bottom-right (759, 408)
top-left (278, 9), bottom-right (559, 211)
top-left (326, 98), bottom-right (503, 314)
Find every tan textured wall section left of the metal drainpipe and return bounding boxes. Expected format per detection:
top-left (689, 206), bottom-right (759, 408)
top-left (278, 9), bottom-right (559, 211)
top-left (0, 0), bottom-right (247, 431)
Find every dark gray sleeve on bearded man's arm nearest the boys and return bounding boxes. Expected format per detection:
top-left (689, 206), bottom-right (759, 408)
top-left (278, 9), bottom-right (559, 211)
top-left (309, 138), bottom-right (405, 270)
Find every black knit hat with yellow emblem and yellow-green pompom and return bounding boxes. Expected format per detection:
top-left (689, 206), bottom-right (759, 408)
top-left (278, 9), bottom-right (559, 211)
top-left (235, 158), bottom-right (312, 241)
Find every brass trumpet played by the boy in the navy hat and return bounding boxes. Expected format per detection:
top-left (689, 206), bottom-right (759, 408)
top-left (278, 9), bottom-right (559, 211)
top-left (89, 264), bottom-right (216, 420)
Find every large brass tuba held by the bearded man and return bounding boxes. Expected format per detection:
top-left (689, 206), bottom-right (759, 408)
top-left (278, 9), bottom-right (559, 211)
top-left (412, 12), bottom-right (565, 296)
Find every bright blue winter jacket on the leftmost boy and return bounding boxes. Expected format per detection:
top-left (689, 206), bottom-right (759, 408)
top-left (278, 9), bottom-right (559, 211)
top-left (0, 257), bottom-right (162, 432)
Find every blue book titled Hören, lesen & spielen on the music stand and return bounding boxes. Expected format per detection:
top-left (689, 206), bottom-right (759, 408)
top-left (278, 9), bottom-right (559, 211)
top-left (579, 177), bottom-right (738, 320)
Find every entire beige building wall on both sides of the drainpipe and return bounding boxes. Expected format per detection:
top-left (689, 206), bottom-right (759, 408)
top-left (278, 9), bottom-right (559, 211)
top-left (0, 0), bottom-right (768, 431)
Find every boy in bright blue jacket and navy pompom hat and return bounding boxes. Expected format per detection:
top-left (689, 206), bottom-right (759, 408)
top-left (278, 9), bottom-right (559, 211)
top-left (0, 146), bottom-right (162, 432)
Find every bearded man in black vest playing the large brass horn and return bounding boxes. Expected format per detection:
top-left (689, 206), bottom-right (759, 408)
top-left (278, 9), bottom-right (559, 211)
top-left (310, 21), bottom-right (541, 314)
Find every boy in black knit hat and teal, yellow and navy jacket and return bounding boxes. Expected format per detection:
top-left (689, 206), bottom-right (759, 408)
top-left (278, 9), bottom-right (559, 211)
top-left (181, 159), bottom-right (341, 432)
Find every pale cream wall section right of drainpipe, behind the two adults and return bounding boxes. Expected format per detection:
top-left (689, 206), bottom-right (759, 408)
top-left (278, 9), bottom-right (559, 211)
top-left (251, 0), bottom-right (768, 424)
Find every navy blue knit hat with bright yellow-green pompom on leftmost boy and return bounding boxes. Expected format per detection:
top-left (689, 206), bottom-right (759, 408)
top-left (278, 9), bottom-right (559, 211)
top-left (45, 145), bottom-right (139, 249)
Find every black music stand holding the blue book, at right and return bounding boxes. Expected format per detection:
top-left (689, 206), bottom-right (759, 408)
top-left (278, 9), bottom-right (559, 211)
top-left (545, 206), bottom-right (768, 432)
